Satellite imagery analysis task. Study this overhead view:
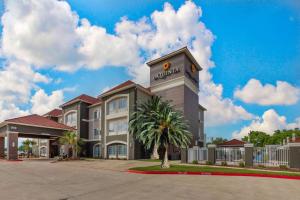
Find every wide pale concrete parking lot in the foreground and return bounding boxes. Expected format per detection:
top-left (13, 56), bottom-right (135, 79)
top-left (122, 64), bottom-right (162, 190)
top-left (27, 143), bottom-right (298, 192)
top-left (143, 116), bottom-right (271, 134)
top-left (0, 160), bottom-right (300, 200)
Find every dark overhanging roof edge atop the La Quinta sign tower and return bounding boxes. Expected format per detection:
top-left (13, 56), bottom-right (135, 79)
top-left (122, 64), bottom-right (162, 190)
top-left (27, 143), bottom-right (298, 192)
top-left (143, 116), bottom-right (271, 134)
top-left (146, 46), bottom-right (202, 71)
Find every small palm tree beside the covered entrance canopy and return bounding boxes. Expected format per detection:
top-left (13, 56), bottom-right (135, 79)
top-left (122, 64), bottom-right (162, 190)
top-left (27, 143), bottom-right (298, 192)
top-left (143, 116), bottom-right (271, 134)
top-left (59, 131), bottom-right (83, 158)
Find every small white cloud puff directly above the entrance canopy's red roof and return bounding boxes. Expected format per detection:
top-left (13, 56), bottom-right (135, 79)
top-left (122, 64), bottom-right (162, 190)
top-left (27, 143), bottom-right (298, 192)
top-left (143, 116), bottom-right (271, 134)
top-left (30, 89), bottom-right (64, 115)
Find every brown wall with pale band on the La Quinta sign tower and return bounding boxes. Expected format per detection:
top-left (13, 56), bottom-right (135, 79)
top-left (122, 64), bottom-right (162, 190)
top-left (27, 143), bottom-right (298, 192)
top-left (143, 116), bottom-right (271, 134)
top-left (150, 53), bottom-right (199, 152)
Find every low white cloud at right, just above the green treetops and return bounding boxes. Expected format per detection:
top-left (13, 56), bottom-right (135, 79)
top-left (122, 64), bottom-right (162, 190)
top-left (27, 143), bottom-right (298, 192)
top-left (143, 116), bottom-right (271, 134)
top-left (232, 109), bottom-right (300, 138)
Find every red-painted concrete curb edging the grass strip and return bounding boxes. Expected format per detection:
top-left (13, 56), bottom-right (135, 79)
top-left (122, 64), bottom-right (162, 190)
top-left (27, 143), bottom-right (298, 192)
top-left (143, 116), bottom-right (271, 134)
top-left (127, 170), bottom-right (300, 180)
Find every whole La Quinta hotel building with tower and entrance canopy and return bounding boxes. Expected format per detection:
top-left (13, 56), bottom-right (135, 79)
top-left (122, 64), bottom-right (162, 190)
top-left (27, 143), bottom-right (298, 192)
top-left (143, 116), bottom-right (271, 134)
top-left (0, 47), bottom-right (205, 161)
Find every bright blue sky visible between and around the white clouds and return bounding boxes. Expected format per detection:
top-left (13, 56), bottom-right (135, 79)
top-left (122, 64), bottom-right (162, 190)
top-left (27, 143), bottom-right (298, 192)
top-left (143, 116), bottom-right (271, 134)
top-left (0, 0), bottom-right (300, 141)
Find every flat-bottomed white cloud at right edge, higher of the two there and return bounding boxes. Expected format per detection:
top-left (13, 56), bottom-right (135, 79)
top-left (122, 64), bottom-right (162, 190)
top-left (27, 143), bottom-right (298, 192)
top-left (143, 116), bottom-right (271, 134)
top-left (234, 79), bottom-right (300, 105)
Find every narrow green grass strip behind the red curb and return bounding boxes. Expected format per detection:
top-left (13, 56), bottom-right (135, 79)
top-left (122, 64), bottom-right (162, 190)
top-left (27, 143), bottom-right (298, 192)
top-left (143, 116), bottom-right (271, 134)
top-left (130, 165), bottom-right (300, 176)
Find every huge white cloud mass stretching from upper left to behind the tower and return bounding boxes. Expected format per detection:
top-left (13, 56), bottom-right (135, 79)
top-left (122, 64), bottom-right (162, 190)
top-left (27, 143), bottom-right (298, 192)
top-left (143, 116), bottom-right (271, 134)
top-left (1, 0), bottom-right (252, 125)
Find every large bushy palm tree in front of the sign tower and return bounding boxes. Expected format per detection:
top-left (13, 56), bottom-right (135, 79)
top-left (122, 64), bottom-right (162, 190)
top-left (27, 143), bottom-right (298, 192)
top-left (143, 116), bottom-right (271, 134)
top-left (129, 97), bottom-right (192, 168)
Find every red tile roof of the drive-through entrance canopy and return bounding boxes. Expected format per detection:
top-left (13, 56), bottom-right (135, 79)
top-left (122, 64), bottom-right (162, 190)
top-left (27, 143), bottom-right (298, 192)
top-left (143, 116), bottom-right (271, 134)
top-left (4, 114), bottom-right (74, 130)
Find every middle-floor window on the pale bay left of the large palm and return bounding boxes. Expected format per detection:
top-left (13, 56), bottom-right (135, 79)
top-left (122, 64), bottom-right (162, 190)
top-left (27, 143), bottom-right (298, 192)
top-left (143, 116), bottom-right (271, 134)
top-left (108, 118), bottom-right (128, 135)
